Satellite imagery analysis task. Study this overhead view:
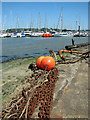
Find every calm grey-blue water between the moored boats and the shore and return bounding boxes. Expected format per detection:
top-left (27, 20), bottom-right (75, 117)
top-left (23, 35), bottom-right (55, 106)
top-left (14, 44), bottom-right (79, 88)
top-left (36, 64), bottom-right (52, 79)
top-left (0, 37), bottom-right (88, 62)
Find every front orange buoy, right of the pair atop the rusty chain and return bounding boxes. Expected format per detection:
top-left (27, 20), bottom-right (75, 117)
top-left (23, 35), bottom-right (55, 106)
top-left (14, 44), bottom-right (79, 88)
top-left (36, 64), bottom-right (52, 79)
top-left (41, 56), bottom-right (55, 70)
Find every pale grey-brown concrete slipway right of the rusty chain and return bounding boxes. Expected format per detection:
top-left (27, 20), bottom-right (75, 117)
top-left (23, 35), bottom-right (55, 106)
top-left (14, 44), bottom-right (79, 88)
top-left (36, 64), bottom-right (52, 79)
top-left (50, 50), bottom-right (88, 118)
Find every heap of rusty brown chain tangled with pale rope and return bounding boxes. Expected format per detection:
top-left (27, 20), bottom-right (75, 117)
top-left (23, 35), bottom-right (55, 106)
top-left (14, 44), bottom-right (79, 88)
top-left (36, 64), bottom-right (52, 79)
top-left (2, 66), bottom-right (58, 119)
